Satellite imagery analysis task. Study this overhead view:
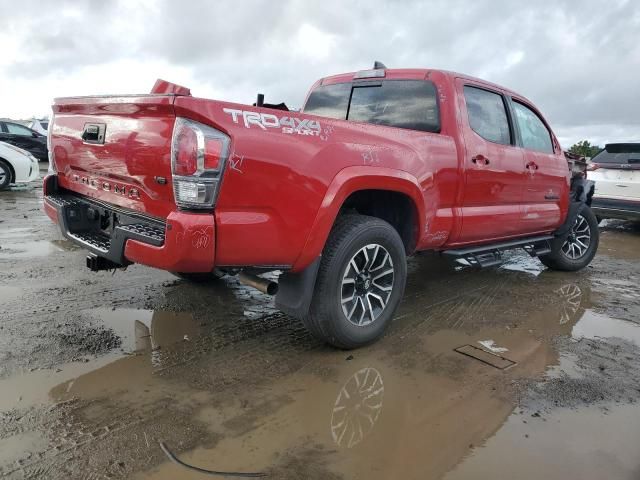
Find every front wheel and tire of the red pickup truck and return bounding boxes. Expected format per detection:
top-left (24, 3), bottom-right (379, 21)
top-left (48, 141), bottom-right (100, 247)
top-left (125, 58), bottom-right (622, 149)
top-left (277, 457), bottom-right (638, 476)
top-left (540, 206), bottom-right (600, 272)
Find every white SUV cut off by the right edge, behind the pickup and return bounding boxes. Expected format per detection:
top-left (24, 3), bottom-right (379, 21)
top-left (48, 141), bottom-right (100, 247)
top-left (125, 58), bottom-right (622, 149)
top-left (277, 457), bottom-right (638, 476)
top-left (587, 143), bottom-right (640, 220)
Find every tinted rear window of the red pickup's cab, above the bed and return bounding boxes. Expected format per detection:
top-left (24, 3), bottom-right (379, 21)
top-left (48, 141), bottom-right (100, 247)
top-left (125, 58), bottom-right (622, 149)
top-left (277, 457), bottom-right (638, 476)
top-left (303, 80), bottom-right (440, 133)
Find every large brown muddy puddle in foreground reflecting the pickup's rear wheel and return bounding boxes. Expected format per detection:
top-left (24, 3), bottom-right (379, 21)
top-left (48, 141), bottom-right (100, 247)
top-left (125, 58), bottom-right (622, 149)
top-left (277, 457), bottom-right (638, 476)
top-left (136, 308), bottom-right (576, 480)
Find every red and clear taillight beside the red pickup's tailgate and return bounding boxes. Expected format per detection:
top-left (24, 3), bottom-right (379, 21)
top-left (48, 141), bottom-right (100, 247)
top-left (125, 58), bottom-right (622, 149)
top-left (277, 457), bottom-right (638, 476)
top-left (171, 117), bottom-right (230, 208)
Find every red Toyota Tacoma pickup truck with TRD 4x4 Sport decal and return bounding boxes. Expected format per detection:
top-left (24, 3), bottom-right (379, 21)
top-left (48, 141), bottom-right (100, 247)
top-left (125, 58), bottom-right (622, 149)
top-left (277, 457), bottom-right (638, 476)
top-left (44, 65), bottom-right (598, 348)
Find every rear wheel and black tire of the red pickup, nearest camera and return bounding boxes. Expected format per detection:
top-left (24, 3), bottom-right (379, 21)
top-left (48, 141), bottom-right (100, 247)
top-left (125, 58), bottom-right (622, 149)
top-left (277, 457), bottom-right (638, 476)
top-left (303, 215), bottom-right (407, 349)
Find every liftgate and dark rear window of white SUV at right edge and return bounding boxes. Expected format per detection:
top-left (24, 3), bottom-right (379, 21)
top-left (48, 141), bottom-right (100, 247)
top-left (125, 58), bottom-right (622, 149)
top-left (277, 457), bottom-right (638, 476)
top-left (589, 143), bottom-right (640, 202)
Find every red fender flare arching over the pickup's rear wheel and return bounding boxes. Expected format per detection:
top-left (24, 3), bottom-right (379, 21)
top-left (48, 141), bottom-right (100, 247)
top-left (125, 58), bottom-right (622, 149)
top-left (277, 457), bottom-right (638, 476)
top-left (291, 166), bottom-right (425, 272)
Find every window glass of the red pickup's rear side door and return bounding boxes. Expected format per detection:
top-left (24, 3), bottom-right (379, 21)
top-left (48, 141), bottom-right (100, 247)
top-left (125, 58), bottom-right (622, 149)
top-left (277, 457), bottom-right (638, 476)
top-left (464, 86), bottom-right (511, 145)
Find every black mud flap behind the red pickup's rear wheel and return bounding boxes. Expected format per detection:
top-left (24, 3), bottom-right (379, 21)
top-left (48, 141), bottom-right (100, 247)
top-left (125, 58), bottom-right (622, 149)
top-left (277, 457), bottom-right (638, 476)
top-left (276, 257), bottom-right (321, 318)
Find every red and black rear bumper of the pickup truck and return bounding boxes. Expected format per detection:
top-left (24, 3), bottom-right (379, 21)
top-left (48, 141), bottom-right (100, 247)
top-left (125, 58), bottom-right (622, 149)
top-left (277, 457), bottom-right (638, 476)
top-left (43, 177), bottom-right (215, 272)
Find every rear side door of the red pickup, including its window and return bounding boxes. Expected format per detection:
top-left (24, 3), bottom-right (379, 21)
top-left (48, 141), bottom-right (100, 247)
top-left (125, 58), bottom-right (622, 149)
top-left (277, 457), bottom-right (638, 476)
top-left (456, 79), bottom-right (524, 243)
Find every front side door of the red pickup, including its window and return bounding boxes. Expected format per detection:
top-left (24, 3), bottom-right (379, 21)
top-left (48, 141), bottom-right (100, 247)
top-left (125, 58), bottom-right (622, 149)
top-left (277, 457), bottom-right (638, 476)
top-left (510, 98), bottom-right (569, 233)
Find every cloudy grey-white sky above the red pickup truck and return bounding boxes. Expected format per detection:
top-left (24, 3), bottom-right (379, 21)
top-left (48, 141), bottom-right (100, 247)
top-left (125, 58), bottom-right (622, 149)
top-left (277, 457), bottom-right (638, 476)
top-left (0, 0), bottom-right (640, 148)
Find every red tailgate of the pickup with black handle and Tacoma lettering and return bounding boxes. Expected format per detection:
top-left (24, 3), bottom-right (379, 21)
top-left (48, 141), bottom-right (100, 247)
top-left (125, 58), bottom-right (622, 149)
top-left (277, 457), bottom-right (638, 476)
top-left (50, 95), bottom-right (175, 218)
